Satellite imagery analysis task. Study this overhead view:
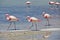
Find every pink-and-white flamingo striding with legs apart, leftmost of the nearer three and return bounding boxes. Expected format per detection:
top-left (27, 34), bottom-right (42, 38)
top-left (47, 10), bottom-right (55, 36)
top-left (5, 14), bottom-right (18, 30)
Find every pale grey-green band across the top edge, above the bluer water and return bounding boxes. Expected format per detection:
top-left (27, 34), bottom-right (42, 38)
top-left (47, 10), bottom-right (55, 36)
top-left (0, 0), bottom-right (59, 6)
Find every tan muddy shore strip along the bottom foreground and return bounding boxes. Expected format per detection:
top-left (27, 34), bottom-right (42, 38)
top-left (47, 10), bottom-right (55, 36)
top-left (0, 28), bottom-right (59, 40)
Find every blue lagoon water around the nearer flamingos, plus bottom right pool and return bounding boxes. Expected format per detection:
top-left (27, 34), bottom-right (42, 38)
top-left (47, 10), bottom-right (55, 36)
top-left (0, 6), bottom-right (60, 40)
